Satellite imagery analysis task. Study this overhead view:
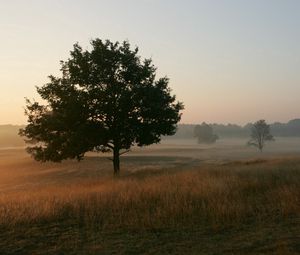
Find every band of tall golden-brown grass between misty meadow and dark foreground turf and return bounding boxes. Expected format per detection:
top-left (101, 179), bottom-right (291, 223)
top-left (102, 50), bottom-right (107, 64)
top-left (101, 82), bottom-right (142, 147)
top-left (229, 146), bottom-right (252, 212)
top-left (0, 160), bottom-right (300, 229)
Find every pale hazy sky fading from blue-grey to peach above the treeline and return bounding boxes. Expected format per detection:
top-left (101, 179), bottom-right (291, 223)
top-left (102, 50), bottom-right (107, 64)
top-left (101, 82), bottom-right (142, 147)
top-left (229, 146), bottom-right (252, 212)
top-left (0, 0), bottom-right (300, 124)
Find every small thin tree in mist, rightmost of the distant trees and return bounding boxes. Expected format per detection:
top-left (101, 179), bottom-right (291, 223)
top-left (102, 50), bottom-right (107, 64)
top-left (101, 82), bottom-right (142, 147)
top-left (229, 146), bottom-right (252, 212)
top-left (248, 120), bottom-right (274, 152)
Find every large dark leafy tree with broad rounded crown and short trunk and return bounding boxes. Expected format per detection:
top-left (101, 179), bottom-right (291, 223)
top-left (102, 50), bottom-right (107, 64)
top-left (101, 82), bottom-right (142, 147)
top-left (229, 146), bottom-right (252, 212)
top-left (20, 39), bottom-right (183, 175)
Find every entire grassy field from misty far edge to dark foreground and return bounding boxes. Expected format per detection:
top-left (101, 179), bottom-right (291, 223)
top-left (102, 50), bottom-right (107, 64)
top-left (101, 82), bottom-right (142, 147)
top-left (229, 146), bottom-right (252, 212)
top-left (0, 138), bottom-right (300, 254)
